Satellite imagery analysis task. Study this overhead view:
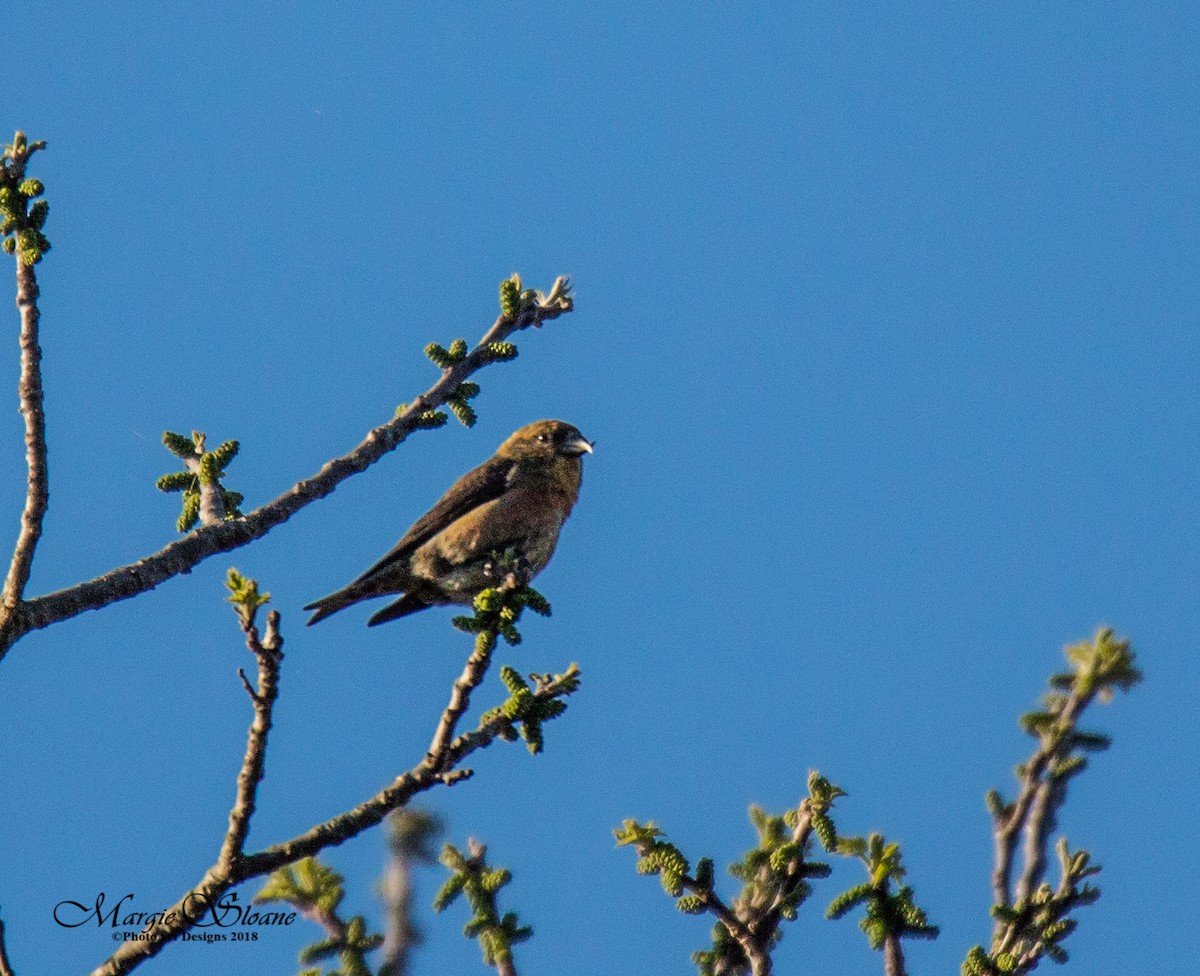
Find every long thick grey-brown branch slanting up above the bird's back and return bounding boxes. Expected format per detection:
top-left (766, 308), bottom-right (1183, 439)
top-left (0, 292), bottom-right (570, 658)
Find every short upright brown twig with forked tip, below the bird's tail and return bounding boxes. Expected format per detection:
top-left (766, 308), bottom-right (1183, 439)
top-left (217, 610), bottom-right (283, 872)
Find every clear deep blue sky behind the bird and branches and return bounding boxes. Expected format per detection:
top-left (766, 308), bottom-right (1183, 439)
top-left (0, 2), bottom-right (1200, 976)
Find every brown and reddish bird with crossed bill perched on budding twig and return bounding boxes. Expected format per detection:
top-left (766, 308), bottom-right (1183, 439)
top-left (305, 420), bottom-right (594, 627)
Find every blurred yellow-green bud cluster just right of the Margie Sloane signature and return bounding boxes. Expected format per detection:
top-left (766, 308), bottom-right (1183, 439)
top-left (254, 857), bottom-right (383, 976)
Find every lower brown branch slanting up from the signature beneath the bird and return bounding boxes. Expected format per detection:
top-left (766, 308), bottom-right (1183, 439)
top-left (92, 638), bottom-right (576, 976)
